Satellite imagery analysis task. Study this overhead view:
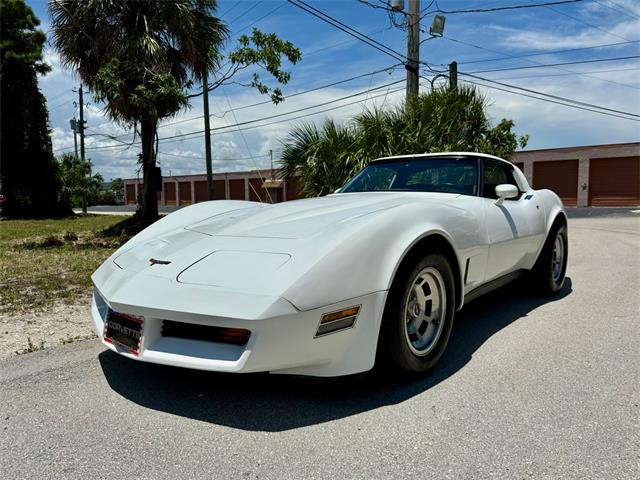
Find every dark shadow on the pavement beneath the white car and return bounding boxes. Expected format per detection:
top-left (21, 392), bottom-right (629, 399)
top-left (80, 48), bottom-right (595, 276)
top-left (99, 278), bottom-right (572, 431)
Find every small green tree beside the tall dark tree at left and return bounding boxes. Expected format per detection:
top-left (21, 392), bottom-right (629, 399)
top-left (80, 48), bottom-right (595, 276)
top-left (58, 153), bottom-right (103, 213)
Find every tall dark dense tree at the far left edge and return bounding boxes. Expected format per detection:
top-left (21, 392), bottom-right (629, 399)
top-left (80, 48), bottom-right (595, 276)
top-left (0, 0), bottom-right (67, 217)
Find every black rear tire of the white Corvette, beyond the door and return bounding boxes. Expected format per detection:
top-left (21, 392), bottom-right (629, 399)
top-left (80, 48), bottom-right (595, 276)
top-left (531, 221), bottom-right (569, 295)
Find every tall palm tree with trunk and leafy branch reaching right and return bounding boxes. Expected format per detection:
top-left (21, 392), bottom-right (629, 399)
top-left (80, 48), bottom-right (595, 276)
top-left (49, 0), bottom-right (300, 219)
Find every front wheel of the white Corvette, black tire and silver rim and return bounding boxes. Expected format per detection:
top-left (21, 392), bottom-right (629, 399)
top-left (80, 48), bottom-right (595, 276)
top-left (378, 253), bottom-right (455, 373)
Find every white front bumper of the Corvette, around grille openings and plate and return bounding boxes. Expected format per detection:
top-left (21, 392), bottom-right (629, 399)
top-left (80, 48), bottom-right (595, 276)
top-left (91, 288), bottom-right (387, 376)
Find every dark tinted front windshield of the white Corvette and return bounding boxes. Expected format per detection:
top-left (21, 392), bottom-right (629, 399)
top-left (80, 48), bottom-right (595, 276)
top-left (340, 157), bottom-right (478, 195)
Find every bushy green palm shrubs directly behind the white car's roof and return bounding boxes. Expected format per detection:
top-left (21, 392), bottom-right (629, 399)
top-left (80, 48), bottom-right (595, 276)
top-left (280, 86), bottom-right (528, 196)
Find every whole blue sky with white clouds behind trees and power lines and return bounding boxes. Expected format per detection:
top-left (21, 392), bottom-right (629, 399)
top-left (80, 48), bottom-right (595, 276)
top-left (27, 0), bottom-right (640, 180)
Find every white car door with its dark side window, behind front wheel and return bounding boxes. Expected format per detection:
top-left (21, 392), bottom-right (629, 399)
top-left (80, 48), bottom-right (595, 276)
top-left (480, 158), bottom-right (544, 281)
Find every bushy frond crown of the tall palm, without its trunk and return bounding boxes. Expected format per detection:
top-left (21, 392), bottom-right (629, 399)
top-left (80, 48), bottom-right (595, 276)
top-left (49, 0), bottom-right (229, 123)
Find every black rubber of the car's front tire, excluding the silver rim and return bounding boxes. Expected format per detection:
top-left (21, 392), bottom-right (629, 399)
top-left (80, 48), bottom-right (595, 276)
top-left (377, 253), bottom-right (456, 373)
